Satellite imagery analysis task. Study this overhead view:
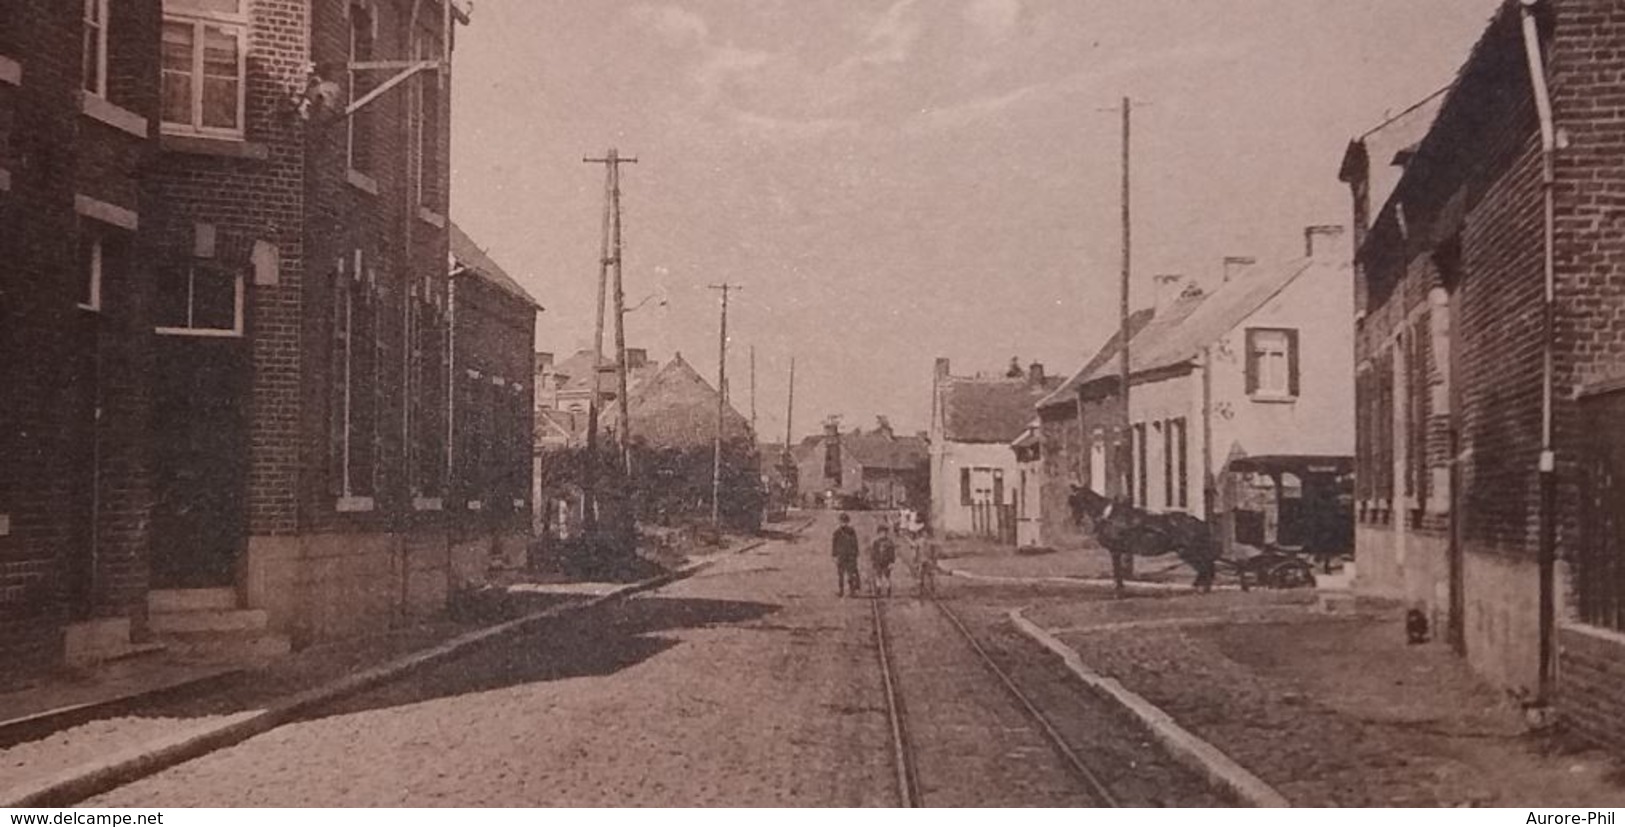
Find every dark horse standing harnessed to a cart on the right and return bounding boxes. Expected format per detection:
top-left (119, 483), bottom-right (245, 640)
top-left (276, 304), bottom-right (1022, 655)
top-left (1066, 486), bottom-right (1220, 595)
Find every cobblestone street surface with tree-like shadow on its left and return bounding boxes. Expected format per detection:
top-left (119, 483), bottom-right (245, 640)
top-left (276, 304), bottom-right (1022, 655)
top-left (57, 518), bottom-right (1224, 806)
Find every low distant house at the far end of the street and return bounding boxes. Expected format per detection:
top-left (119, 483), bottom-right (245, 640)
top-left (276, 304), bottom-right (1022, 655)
top-left (796, 419), bottom-right (931, 509)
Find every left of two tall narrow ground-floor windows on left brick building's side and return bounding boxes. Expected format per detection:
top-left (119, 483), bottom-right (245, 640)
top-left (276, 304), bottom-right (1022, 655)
top-left (330, 250), bottom-right (382, 500)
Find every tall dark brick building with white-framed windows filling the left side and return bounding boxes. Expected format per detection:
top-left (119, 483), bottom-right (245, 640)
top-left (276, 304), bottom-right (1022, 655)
top-left (0, 0), bottom-right (494, 665)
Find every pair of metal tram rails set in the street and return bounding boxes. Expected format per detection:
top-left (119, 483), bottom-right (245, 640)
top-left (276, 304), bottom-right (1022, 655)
top-left (869, 549), bottom-right (1120, 808)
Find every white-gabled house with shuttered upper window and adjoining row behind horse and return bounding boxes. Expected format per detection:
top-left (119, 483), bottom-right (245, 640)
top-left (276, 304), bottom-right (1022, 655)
top-left (1037, 226), bottom-right (1354, 551)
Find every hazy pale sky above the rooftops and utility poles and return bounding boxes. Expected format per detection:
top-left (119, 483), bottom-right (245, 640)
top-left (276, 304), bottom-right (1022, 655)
top-left (452, 0), bottom-right (1497, 440)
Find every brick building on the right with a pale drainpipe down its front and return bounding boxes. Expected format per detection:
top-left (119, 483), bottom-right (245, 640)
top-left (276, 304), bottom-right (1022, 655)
top-left (1344, 0), bottom-right (1625, 744)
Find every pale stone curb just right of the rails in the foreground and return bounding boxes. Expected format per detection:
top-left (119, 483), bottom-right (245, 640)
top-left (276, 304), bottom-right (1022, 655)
top-left (1009, 609), bottom-right (1292, 808)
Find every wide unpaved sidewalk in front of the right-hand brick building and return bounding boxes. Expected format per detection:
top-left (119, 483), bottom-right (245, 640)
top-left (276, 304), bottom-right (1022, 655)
top-left (1025, 591), bottom-right (1625, 808)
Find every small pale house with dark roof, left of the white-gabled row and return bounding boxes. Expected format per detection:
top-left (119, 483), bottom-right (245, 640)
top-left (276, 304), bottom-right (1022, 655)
top-left (930, 359), bottom-right (1060, 544)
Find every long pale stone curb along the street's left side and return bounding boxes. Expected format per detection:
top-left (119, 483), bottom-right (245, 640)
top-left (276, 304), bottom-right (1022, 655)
top-left (0, 523), bottom-right (786, 809)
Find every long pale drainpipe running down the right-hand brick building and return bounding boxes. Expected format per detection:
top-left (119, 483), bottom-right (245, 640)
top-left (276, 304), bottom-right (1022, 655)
top-left (1521, 0), bottom-right (1557, 705)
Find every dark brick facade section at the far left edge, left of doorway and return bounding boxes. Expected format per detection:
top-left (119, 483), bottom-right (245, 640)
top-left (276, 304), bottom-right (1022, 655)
top-left (0, 0), bottom-right (159, 681)
